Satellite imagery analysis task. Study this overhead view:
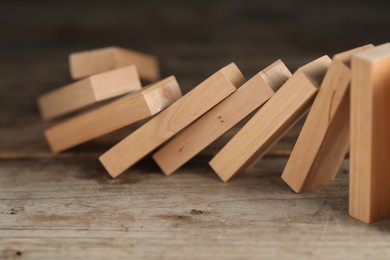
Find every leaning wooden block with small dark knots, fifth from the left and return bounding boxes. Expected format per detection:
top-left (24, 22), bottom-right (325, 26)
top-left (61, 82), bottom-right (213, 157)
top-left (153, 60), bottom-right (291, 175)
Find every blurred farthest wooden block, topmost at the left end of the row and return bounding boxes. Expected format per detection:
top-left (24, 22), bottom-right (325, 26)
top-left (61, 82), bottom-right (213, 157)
top-left (69, 47), bottom-right (160, 82)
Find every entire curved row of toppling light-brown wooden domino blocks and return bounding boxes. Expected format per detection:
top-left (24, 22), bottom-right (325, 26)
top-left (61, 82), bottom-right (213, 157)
top-left (38, 43), bottom-right (390, 222)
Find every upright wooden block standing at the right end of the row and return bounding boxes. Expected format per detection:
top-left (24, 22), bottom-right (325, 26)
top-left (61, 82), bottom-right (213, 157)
top-left (349, 43), bottom-right (390, 223)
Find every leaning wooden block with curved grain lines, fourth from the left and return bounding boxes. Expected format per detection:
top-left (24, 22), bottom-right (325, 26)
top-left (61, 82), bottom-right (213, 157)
top-left (100, 63), bottom-right (245, 177)
